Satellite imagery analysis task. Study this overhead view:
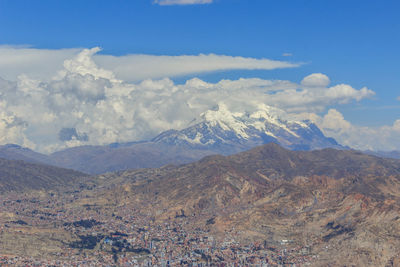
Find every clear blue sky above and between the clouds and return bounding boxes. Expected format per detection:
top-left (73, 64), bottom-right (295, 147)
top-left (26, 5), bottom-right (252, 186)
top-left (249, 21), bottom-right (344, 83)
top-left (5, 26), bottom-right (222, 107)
top-left (0, 0), bottom-right (400, 151)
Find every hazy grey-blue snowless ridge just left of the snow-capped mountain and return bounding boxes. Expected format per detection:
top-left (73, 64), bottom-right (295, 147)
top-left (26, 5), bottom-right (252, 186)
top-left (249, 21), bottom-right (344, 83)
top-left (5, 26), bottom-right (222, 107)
top-left (50, 142), bottom-right (213, 174)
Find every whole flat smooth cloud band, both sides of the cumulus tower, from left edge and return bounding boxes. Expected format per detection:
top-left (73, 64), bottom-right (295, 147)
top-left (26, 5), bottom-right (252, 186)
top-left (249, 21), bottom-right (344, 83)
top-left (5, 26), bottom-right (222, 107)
top-left (0, 46), bottom-right (300, 82)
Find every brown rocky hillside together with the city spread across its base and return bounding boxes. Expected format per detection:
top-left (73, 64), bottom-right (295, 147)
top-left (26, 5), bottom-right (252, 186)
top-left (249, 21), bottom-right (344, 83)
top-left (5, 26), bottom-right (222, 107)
top-left (0, 143), bottom-right (400, 266)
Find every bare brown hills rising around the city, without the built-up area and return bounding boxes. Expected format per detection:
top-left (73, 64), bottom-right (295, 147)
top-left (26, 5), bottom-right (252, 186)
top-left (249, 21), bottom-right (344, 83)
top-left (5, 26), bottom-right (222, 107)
top-left (0, 143), bottom-right (400, 266)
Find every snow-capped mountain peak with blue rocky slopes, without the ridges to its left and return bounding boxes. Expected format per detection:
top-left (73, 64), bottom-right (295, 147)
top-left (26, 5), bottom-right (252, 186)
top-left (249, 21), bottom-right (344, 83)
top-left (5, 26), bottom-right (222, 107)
top-left (152, 104), bottom-right (341, 154)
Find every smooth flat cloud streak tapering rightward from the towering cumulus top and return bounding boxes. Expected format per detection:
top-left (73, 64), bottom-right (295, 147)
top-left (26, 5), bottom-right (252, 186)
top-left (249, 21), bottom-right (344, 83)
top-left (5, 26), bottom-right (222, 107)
top-left (94, 54), bottom-right (300, 82)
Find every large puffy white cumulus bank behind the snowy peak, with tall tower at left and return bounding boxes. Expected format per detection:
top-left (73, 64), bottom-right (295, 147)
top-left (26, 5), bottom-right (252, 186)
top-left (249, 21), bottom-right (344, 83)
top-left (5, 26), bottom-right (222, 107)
top-left (0, 48), bottom-right (378, 152)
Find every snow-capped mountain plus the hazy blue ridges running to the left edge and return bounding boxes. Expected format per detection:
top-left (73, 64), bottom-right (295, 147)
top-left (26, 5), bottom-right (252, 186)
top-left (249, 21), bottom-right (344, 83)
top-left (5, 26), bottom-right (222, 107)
top-left (0, 104), bottom-right (344, 174)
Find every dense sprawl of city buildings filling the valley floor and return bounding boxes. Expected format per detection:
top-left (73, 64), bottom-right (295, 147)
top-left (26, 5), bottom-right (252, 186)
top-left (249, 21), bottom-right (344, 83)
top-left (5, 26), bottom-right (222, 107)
top-left (0, 194), bottom-right (313, 266)
